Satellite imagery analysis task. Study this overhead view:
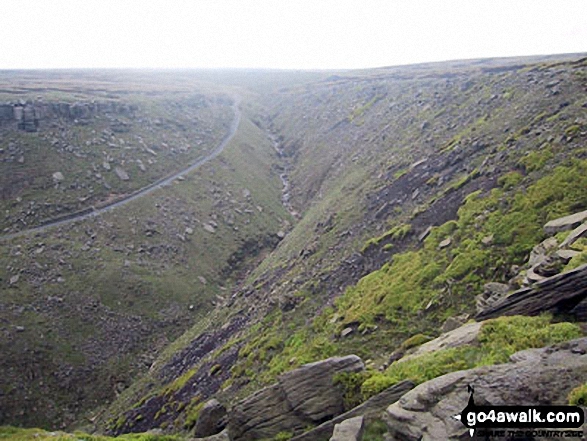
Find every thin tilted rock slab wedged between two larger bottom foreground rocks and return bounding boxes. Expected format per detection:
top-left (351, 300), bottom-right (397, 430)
top-left (291, 380), bottom-right (415, 441)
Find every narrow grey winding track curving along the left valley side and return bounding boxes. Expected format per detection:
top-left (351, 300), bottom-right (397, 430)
top-left (0, 98), bottom-right (241, 242)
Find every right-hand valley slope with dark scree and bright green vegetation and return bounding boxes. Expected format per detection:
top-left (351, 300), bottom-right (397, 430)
top-left (97, 55), bottom-right (587, 434)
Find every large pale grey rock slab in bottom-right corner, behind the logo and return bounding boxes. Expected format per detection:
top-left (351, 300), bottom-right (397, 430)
top-left (384, 338), bottom-right (587, 441)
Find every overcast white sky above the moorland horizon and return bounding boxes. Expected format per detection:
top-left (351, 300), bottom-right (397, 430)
top-left (0, 0), bottom-right (587, 69)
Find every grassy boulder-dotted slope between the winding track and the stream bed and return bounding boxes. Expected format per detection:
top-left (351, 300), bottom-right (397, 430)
top-left (0, 76), bottom-right (289, 427)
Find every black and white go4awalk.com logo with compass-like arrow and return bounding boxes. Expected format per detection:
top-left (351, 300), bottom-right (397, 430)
top-left (453, 386), bottom-right (585, 438)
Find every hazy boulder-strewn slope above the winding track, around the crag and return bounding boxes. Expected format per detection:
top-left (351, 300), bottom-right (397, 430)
top-left (0, 72), bottom-right (232, 232)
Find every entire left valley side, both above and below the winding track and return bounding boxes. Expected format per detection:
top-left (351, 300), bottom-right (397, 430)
top-left (0, 73), bottom-right (289, 427)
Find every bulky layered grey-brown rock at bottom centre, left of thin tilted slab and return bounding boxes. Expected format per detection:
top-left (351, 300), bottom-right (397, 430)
top-left (228, 355), bottom-right (365, 441)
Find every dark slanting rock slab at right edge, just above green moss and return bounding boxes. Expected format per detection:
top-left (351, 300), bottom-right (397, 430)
top-left (475, 264), bottom-right (587, 320)
